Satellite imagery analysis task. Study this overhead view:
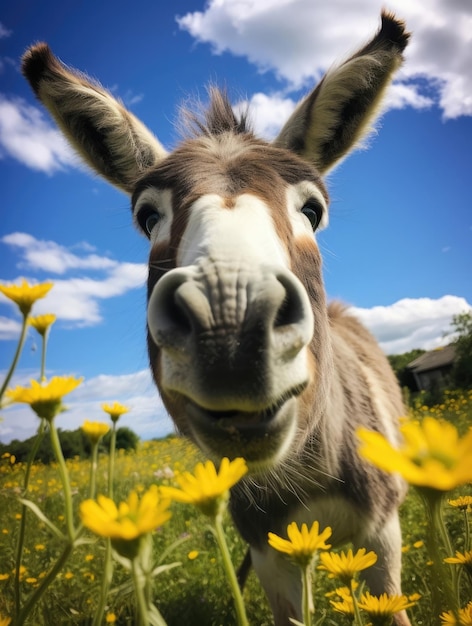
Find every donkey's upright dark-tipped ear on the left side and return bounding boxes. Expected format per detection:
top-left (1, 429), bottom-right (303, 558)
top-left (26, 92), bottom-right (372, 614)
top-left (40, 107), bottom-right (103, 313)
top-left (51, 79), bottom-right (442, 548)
top-left (22, 43), bottom-right (166, 193)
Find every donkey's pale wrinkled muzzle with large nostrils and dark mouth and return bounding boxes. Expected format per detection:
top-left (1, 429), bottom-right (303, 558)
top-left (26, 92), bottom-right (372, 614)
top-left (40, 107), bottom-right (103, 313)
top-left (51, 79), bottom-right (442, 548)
top-left (148, 263), bottom-right (313, 458)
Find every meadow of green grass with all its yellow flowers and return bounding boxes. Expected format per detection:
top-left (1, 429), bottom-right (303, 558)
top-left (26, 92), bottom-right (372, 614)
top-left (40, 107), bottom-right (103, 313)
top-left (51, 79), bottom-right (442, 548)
top-left (0, 283), bottom-right (472, 626)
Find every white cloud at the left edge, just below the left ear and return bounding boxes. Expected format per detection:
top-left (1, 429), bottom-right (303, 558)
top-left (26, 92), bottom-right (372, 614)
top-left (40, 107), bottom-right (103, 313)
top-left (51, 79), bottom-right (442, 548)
top-left (0, 94), bottom-right (79, 174)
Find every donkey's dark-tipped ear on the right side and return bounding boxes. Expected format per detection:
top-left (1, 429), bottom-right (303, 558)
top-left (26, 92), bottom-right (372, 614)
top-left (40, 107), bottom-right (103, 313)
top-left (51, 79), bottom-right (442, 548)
top-left (275, 12), bottom-right (410, 173)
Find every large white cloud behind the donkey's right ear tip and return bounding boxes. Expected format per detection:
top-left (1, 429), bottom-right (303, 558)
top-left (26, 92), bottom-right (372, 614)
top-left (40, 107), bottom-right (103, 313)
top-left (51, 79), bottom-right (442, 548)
top-left (177, 0), bottom-right (472, 118)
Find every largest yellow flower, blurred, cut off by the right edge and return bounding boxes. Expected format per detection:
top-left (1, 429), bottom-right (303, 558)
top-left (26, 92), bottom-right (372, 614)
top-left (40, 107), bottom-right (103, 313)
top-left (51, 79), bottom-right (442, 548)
top-left (357, 417), bottom-right (472, 491)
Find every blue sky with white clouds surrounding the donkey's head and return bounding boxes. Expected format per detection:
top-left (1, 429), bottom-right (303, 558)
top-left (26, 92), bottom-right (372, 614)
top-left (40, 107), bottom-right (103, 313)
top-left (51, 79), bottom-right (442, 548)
top-left (0, 0), bottom-right (472, 442)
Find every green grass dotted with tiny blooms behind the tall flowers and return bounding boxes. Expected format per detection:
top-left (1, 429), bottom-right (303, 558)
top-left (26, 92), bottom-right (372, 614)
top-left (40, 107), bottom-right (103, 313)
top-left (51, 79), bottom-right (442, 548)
top-left (0, 392), bottom-right (472, 626)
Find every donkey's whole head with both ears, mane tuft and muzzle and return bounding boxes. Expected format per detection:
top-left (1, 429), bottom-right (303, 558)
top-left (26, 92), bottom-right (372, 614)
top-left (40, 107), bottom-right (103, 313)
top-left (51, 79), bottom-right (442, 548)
top-left (23, 14), bottom-right (408, 467)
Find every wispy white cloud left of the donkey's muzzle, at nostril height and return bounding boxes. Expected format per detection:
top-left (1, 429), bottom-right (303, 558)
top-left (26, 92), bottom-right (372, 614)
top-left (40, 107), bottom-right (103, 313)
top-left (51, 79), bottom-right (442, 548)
top-left (0, 233), bottom-right (147, 326)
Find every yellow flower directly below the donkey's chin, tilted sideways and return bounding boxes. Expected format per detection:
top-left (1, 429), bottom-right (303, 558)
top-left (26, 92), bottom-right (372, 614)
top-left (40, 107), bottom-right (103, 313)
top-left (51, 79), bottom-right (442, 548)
top-left (160, 457), bottom-right (247, 517)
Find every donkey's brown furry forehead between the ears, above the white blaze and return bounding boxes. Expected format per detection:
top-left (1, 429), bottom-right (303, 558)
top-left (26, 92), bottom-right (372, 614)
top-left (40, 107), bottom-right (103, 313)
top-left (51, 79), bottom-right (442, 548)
top-left (133, 133), bottom-right (328, 204)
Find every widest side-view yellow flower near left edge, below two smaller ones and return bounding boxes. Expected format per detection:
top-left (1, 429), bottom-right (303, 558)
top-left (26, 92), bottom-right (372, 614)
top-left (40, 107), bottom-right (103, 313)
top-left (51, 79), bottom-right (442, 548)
top-left (7, 376), bottom-right (83, 421)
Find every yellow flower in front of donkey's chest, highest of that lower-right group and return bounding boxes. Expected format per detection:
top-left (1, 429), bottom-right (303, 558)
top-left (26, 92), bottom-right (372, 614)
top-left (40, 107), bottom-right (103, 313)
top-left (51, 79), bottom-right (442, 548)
top-left (269, 522), bottom-right (332, 567)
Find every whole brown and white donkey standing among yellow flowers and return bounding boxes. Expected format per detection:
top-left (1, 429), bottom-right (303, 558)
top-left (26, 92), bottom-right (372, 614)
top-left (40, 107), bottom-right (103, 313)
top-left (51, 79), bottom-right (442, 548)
top-left (23, 12), bottom-right (410, 626)
